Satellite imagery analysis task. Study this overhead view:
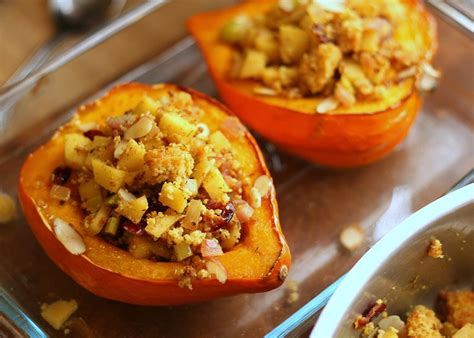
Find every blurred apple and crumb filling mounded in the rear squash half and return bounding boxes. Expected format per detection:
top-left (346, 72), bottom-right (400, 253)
top-left (221, 0), bottom-right (439, 113)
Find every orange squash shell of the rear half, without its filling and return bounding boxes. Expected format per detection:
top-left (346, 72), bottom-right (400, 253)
top-left (188, 0), bottom-right (437, 167)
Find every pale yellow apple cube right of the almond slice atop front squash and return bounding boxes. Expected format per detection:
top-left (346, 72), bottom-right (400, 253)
top-left (159, 113), bottom-right (198, 143)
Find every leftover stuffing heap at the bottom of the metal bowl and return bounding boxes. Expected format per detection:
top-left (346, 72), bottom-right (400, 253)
top-left (354, 291), bottom-right (474, 338)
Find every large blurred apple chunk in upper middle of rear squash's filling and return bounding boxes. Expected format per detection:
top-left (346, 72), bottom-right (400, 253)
top-left (279, 25), bottom-right (309, 64)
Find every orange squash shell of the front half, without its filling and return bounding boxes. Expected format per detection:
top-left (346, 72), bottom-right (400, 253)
top-left (19, 83), bottom-right (291, 305)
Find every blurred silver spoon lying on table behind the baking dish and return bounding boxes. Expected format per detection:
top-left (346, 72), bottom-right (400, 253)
top-left (5, 0), bottom-right (126, 85)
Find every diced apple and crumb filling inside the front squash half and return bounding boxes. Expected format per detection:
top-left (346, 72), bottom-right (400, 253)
top-left (50, 92), bottom-right (272, 287)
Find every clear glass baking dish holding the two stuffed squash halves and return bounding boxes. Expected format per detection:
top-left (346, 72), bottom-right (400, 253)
top-left (0, 1), bottom-right (474, 337)
